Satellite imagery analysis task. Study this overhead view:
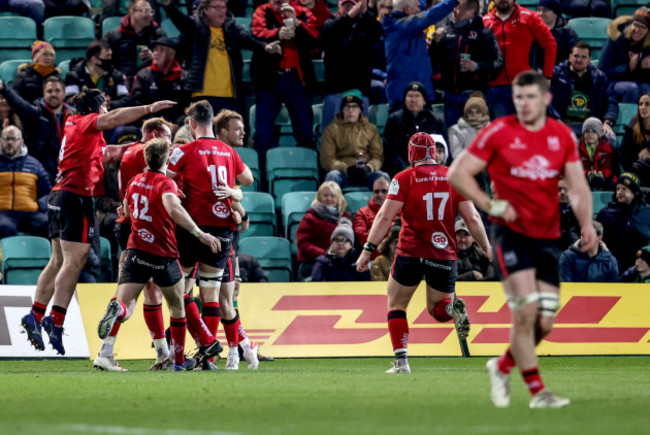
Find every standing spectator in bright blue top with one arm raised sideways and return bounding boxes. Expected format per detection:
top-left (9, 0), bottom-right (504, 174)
top-left (383, 0), bottom-right (458, 107)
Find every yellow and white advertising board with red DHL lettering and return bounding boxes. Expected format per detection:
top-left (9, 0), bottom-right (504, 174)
top-left (0, 282), bottom-right (650, 359)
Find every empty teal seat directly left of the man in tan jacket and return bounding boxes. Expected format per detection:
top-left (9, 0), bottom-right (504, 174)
top-left (266, 147), bottom-right (319, 205)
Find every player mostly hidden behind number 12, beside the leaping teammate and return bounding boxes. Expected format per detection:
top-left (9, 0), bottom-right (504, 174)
top-left (93, 117), bottom-right (172, 371)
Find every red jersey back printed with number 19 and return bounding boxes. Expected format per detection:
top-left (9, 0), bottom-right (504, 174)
top-left (169, 138), bottom-right (245, 226)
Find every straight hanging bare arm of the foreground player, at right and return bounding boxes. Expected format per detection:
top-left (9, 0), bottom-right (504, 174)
top-left (564, 161), bottom-right (598, 252)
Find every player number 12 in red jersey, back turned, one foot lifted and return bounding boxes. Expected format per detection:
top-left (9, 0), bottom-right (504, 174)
top-left (97, 138), bottom-right (221, 371)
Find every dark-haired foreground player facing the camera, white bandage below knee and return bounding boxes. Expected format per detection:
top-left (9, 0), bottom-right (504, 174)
top-left (449, 71), bottom-right (597, 408)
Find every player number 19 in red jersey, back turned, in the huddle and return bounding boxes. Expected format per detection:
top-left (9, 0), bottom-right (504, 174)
top-left (169, 100), bottom-right (258, 370)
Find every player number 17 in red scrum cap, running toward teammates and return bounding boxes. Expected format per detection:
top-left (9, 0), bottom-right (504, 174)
top-left (357, 133), bottom-right (491, 373)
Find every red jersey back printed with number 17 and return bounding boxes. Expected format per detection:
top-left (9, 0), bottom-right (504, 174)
top-left (388, 165), bottom-right (464, 260)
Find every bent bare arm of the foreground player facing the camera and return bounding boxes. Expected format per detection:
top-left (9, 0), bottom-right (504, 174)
top-left (447, 151), bottom-right (517, 222)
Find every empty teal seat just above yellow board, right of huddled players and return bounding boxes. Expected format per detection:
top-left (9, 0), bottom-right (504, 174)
top-left (239, 237), bottom-right (293, 282)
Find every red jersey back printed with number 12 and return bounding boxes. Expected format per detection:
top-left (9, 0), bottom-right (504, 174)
top-left (126, 171), bottom-right (178, 258)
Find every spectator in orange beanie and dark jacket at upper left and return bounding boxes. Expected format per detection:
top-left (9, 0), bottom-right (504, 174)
top-left (13, 41), bottom-right (61, 104)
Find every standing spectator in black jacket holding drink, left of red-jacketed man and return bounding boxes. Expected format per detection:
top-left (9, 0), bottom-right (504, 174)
top-left (429, 0), bottom-right (503, 127)
